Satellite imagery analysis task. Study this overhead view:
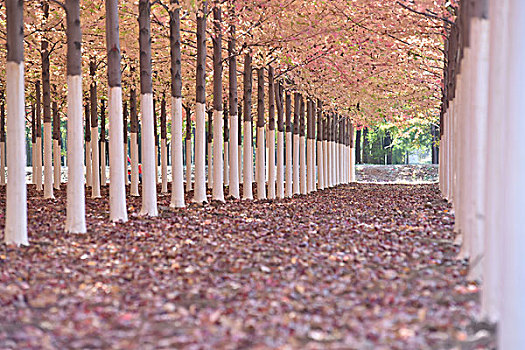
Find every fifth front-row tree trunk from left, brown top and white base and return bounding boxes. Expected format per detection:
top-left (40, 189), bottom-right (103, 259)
top-left (170, 0), bottom-right (185, 208)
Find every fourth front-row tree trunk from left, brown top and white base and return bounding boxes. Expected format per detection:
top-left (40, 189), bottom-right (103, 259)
top-left (139, 0), bottom-right (158, 216)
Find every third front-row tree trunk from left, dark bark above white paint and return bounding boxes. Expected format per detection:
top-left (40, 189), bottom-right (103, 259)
top-left (102, 0), bottom-right (128, 222)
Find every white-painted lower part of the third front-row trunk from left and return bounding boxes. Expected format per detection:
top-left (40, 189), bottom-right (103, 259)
top-left (107, 86), bottom-right (128, 222)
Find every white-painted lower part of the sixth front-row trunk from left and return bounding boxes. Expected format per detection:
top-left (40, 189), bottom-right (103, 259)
top-left (193, 102), bottom-right (210, 203)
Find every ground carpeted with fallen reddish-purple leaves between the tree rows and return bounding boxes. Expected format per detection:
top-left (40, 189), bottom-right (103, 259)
top-left (0, 178), bottom-right (490, 349)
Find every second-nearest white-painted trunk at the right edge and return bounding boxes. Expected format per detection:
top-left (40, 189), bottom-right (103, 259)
top-left (482, 0), bottom-right (509, 322)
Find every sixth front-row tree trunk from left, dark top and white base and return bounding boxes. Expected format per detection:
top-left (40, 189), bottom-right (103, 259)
top-left (193, 1), bottom-right (207, 203)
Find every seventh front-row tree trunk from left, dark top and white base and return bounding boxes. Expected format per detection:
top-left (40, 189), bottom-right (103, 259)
top-left (212, 0), bottom-right (224, 202)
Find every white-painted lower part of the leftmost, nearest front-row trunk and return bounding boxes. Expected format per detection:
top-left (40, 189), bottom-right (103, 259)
top-left (4, 61), bottom-right (29, 245)
